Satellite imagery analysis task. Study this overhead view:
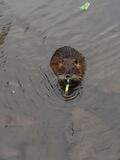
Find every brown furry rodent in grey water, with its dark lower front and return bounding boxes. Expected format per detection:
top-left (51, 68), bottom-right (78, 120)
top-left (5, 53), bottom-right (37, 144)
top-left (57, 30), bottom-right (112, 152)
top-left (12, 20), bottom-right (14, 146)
top-left (50, 46), bottom-right (86, 96)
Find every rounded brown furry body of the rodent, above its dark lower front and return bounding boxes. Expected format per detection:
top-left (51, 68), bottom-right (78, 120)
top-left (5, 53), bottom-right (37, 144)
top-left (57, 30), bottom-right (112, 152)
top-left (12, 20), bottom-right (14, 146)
top-left (50, 46), bottom-right (86, 81)
